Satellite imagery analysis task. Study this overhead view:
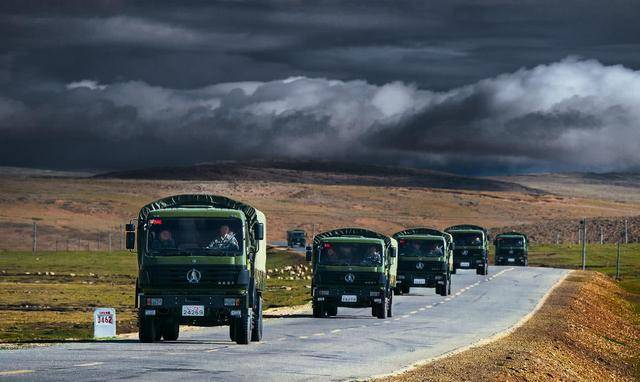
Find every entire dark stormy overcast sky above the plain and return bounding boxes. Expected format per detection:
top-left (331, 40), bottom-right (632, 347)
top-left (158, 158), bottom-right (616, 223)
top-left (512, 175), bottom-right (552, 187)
top-left (0, 0), bottom-right (640, 174)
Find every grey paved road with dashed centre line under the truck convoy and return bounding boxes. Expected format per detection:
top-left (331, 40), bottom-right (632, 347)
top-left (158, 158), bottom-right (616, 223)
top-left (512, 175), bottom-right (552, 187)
top-left (0, 266), bottom-right (566, 381)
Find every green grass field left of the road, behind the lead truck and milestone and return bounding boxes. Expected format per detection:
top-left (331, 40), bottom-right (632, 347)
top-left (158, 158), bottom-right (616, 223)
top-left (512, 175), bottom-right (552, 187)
top-left (0, 248), bottom-right (310, 342)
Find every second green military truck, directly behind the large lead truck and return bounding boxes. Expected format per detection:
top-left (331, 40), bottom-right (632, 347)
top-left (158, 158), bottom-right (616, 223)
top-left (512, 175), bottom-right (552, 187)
top-left (307, 228), bottom-right (398, 319)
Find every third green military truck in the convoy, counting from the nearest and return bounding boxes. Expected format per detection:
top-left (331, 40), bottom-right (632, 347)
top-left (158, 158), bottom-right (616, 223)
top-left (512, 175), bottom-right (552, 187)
top-left (393, 228), bottom-right (453, 296)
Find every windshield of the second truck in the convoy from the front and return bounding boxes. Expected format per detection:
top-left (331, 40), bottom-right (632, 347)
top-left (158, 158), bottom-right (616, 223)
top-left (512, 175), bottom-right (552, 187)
top-left (318, 243), bottom-right (382, 266)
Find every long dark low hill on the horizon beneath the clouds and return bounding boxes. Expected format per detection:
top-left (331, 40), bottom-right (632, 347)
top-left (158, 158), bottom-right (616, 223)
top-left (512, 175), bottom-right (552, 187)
top-left (96, 160), bottom-right (543, 194)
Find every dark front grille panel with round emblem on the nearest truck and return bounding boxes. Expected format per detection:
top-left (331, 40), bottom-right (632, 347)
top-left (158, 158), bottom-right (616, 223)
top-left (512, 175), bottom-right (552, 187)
top-left (145, 265), bottom-right (242, 288)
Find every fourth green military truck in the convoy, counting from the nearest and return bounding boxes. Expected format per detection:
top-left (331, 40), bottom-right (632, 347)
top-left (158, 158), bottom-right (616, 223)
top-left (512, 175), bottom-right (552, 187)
top-left (444, 224), bottom-right (489, 275)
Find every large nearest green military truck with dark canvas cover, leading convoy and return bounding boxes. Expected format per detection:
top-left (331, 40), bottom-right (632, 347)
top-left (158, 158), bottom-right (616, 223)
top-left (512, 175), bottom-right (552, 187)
top-left (126, 195), bottom-right (267, 344)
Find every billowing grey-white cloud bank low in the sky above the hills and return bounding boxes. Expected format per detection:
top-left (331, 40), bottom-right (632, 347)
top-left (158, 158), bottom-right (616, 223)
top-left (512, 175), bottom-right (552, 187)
top-left (0, 58), bottom-right (640, 174)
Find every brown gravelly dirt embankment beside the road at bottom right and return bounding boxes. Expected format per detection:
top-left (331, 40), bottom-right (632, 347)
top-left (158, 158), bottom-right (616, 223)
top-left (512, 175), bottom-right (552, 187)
top-left (380, 272), bottom-right (640, 382)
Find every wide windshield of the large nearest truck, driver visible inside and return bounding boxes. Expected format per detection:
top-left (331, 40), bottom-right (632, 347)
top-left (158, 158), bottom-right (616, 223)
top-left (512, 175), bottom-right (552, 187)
top-left (147, 218), bottom-right (242, 256)
